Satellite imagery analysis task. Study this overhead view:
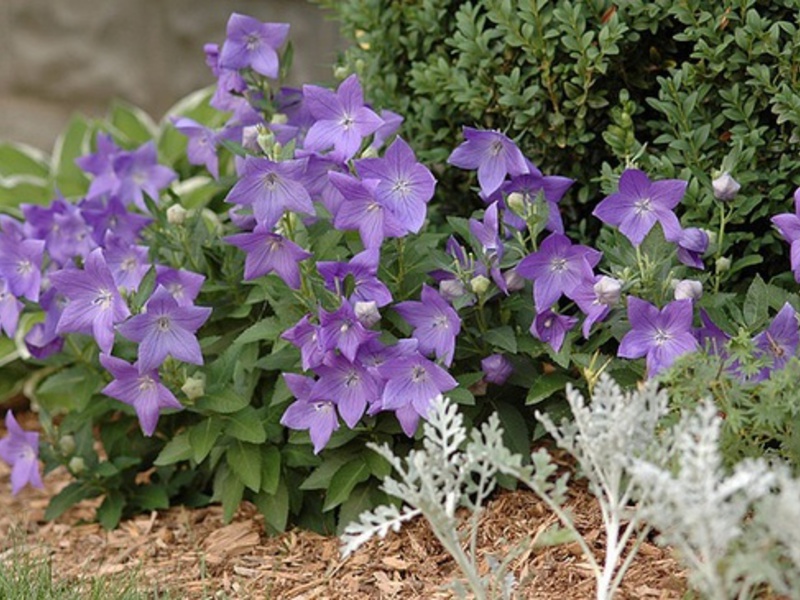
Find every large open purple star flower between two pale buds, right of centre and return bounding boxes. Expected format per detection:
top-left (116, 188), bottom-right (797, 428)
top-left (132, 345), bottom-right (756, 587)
top-left (516, 233), bottom-right (602, 312)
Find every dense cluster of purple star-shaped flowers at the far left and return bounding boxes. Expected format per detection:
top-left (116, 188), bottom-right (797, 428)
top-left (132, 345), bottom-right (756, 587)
top-left (0, 133), bottom-right (211, 435)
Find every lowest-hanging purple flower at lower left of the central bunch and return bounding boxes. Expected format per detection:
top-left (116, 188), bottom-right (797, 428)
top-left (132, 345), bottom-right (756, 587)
top-left (281, 373), bottom-right (339, 454)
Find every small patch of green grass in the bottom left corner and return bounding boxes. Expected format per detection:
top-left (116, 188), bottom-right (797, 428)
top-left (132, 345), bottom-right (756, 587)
top-left (0, 539), bottom-right (170, 600)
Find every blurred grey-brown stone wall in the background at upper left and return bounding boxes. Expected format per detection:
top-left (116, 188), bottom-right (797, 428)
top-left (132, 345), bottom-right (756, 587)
top-left (0, 0), bottom-right (341, 151)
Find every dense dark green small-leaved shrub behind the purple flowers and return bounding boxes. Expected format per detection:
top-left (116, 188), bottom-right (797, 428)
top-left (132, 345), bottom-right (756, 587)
top-left (317, 0), bottom-right (800, 282)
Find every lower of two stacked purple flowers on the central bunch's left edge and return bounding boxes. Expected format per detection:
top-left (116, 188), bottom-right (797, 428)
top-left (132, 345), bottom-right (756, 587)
top-left (224, 225), bottom-right (311, 290)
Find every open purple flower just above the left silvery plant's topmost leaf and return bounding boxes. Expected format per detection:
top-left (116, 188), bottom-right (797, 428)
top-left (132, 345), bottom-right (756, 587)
top-left (309, 355), bottom-right (381, 429)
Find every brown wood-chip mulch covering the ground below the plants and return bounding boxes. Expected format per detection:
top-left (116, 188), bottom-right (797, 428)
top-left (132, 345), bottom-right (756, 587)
top-left (0, 415), bottom-right (686, 600)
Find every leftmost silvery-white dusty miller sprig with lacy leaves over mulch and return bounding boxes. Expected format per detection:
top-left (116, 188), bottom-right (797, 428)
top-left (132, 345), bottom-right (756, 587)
top-left (342, 395), bottom-right (521, 600)
